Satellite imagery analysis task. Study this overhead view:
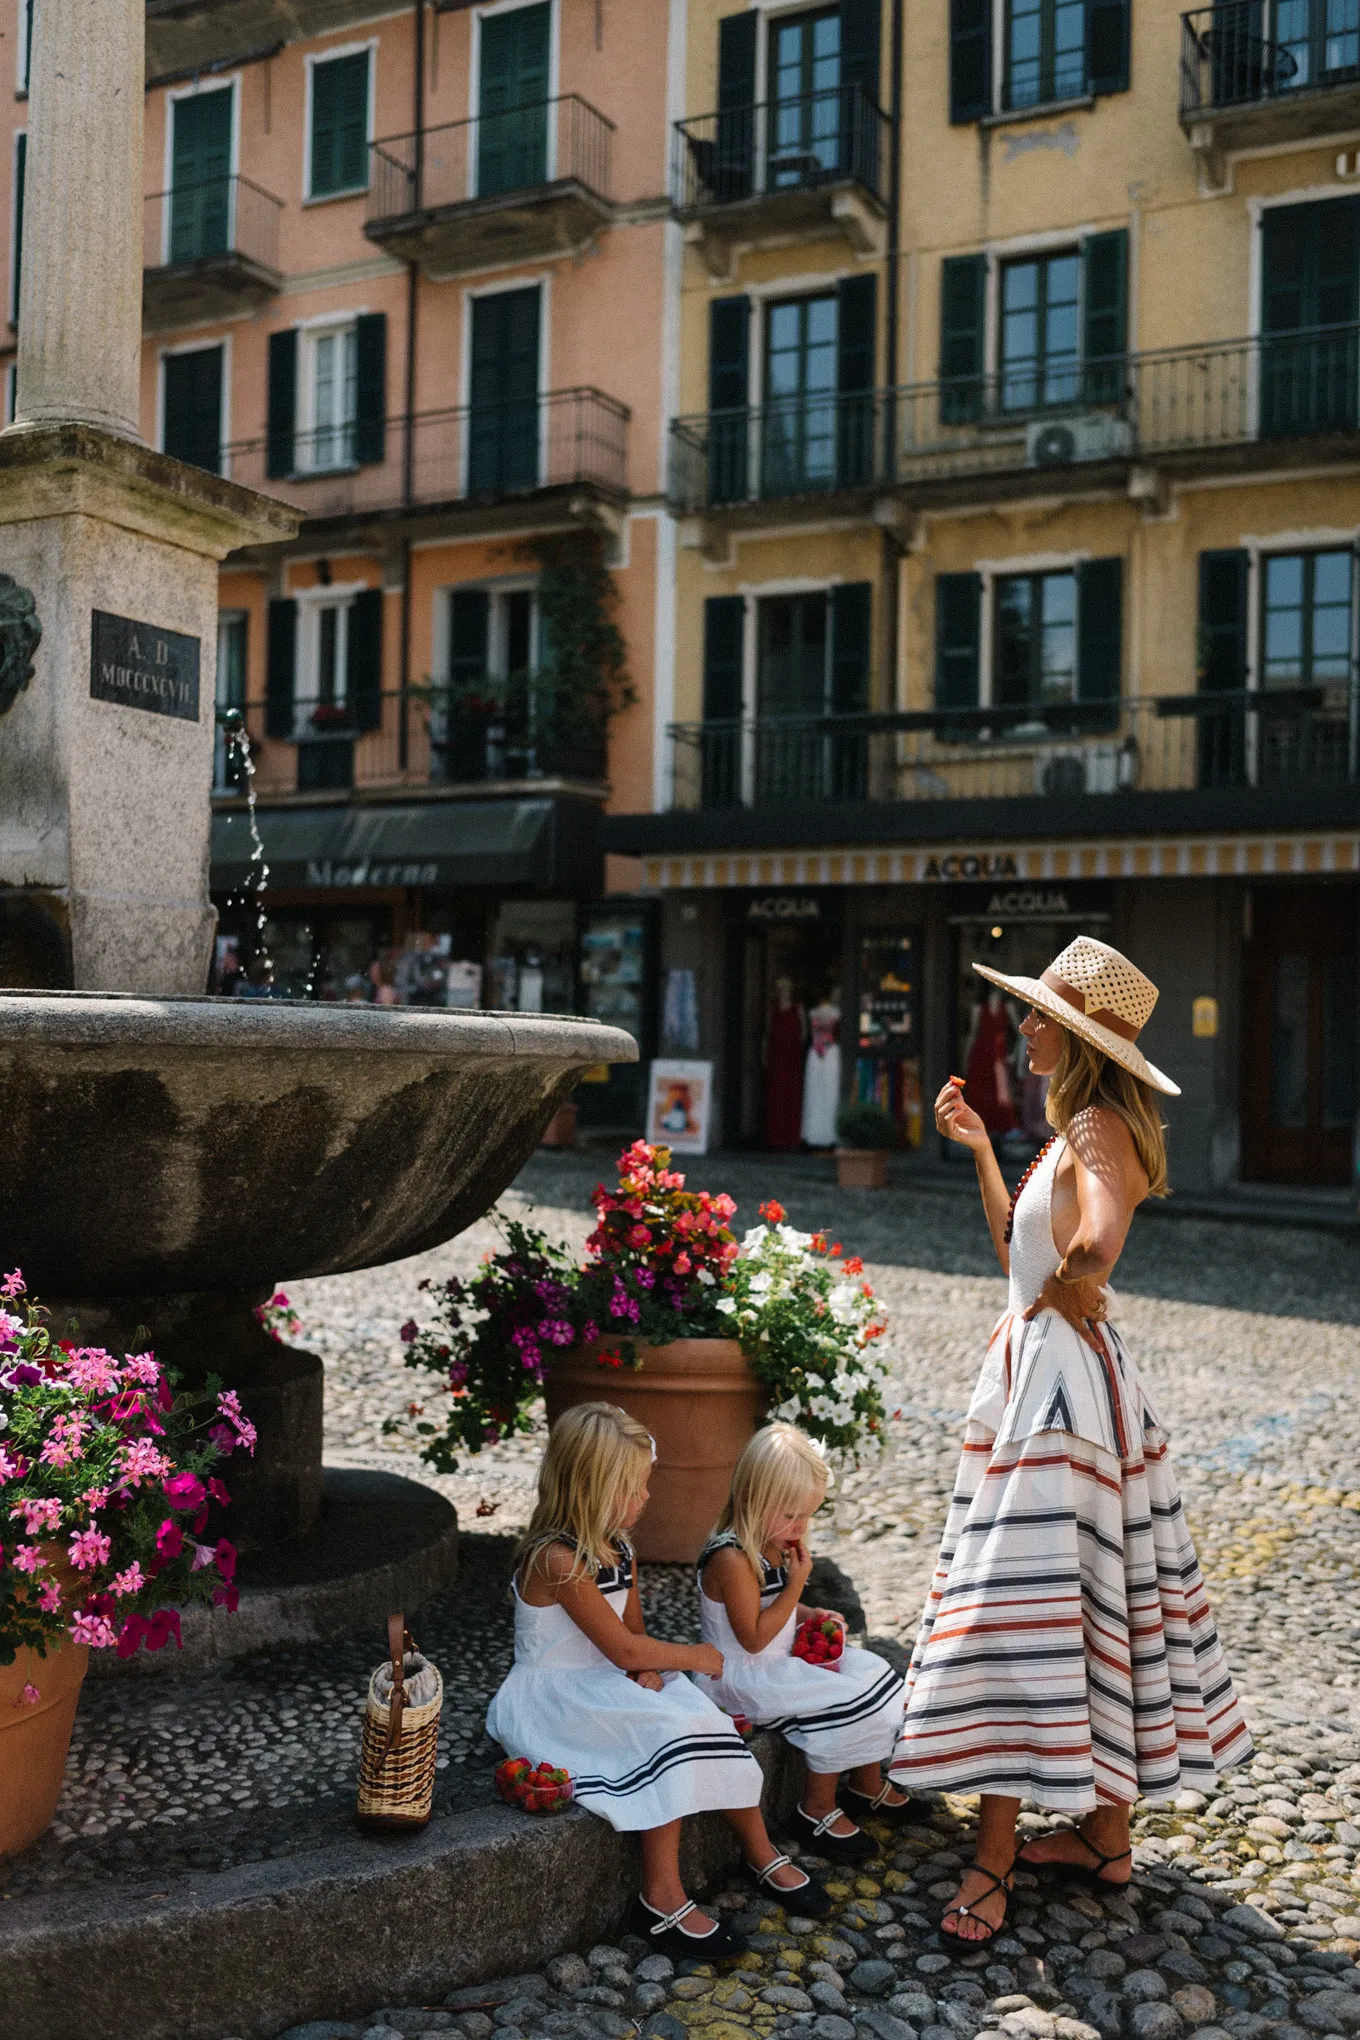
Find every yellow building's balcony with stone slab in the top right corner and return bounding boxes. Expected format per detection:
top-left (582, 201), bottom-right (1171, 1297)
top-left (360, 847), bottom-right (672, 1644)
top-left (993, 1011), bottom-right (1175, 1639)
top-left (1181, 0), bottom-right (1360, 165)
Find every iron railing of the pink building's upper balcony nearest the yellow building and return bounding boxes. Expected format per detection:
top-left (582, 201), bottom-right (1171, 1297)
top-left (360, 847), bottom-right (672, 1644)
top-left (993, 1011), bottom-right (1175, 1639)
top-left (367, 92), bottom-right (614, 224)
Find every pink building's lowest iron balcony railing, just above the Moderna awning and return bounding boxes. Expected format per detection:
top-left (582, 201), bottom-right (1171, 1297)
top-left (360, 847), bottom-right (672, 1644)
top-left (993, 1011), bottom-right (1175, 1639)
top-left (212, 679), bottom-right (606, 796)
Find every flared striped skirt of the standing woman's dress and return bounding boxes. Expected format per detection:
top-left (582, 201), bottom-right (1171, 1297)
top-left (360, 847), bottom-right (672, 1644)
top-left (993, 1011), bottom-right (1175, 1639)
top-left (891, 1312), bottom-right (1252, 1816)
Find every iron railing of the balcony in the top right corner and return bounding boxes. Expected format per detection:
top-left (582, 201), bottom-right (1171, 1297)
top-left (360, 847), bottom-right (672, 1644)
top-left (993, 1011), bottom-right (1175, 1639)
top-left (1181, 0), bottom-right (1360, 122)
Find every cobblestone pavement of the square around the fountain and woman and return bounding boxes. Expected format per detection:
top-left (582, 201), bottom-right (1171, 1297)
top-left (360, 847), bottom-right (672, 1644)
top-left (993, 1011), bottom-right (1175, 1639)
top-left (0, 1157), bottom-right (1360, 2040)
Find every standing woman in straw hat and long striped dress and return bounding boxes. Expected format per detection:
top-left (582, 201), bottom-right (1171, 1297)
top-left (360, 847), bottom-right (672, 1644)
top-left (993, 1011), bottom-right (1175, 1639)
top-left (891, 934), bottom-right (1252, 1944)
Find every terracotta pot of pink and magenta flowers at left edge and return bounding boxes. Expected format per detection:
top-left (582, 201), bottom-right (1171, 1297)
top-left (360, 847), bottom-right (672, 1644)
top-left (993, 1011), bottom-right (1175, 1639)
top-left (0, 1271), bottom-right (255, 1856)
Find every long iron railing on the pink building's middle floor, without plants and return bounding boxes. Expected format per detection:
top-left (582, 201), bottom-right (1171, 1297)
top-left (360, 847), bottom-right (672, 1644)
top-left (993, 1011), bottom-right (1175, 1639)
top-left (222, 390), bottom-right (630, 518)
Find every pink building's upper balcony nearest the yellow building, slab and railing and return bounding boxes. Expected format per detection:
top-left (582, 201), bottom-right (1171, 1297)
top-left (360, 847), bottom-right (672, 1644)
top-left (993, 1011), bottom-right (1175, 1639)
top-left (363, 94), bottom-right (614, 277)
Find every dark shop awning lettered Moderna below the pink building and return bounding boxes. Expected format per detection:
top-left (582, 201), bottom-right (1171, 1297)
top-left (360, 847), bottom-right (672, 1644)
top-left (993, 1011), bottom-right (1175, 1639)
top-left (212, 798), bottom-right (601, 894)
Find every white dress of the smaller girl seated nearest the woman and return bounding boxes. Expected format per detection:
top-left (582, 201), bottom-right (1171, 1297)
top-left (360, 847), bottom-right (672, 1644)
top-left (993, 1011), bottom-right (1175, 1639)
top-left (695, 1532), bottom-right (901, 1775)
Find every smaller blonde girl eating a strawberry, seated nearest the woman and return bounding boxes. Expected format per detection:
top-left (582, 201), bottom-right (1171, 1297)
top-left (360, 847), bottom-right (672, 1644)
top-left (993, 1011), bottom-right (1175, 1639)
top-left (699, 1424), bottom-right (911, 1863)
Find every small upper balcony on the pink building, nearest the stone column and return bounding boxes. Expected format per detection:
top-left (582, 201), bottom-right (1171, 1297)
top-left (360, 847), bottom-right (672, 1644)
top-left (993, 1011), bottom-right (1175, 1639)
top-left (141, 177), bottom-right (283, 333)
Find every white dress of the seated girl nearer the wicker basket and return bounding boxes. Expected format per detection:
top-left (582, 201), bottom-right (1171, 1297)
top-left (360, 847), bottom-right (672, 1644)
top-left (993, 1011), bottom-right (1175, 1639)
top-left (487, 1542), bottom-right (765, 1834)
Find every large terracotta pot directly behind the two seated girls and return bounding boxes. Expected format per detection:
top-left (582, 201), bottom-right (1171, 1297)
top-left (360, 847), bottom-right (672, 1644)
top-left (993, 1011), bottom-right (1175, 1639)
top-left (542, 1338), bottom-right (765, 1561)
